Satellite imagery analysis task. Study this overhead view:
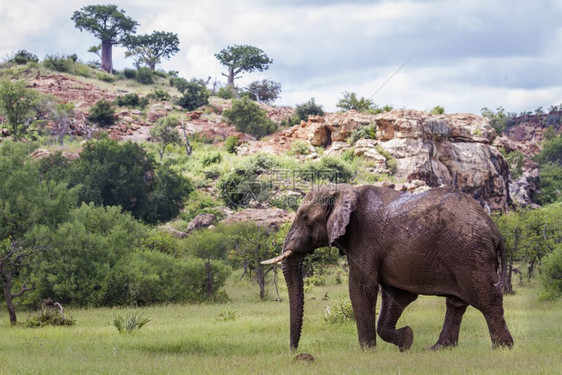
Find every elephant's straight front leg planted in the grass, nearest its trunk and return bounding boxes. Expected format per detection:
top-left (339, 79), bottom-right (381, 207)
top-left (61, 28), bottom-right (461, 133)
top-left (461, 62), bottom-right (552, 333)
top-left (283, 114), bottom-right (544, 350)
top-left (349, 274), bottom-right (379, 348)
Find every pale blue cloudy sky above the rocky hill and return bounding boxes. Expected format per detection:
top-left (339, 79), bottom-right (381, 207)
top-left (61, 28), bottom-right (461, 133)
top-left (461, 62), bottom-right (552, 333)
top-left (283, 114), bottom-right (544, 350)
top-left (0, 0), bottom-right (562, 113)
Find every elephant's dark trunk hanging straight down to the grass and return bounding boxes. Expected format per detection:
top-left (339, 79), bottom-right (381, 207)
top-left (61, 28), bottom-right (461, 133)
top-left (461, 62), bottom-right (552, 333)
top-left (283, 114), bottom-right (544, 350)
top-left (282, 256), bottom-right (304, 350)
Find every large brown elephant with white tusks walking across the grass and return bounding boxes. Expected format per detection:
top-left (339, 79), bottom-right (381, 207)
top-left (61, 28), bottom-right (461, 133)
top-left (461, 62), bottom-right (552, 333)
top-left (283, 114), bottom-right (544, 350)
top-left (263, 185), bottom-right (513, 350)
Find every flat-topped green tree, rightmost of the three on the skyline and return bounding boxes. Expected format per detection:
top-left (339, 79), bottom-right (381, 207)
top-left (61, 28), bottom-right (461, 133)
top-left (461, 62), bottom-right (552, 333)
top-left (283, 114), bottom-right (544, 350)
top-left (215, 45), bottom-right (273, 87)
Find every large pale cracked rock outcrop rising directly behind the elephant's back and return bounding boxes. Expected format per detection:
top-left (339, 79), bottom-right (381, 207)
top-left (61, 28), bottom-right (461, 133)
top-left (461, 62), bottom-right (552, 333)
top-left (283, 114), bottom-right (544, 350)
top-left (286, 110), bottom-right (510, 210)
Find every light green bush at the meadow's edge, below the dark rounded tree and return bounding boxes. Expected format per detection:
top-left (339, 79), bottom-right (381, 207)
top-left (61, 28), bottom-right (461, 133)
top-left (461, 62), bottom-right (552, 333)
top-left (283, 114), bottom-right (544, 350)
top-left (35, 204), bottom-right (147, 306)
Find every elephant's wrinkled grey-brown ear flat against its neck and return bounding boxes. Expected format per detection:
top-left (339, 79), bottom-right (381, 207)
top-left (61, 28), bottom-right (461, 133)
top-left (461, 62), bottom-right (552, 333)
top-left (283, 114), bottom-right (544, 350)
top-left (326, 187), bottom-right (357, 245)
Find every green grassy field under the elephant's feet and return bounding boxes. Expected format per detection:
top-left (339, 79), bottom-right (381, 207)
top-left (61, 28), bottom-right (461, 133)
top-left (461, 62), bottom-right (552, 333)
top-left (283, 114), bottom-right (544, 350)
top-left (0, 277), bottom-right (562, 374)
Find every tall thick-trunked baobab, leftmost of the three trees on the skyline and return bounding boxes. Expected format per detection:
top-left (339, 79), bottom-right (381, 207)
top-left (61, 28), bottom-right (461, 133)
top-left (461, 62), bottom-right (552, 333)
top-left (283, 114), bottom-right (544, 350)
top-left (71, 4), bottom-right (138, 73)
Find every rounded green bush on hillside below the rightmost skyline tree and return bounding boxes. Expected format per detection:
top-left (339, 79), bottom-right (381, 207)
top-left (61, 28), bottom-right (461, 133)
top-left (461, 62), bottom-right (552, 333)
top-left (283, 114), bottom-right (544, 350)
top-left (223, 98), bottom-right (277, 138)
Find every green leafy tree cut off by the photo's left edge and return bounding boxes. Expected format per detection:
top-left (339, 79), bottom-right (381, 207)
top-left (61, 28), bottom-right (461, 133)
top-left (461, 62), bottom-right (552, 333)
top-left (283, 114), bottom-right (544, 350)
top-left (0, 141), bottom-right (76, 324)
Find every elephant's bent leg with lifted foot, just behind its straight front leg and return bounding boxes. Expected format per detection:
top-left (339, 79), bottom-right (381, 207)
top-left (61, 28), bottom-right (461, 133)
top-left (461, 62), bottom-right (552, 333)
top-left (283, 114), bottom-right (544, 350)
top-left (377, 286), bottom-right (418, 351)
